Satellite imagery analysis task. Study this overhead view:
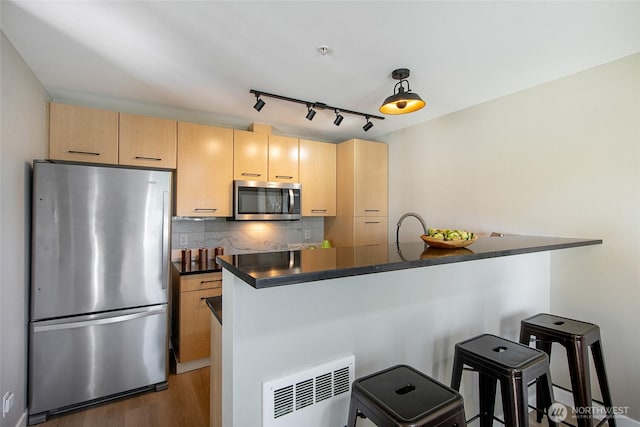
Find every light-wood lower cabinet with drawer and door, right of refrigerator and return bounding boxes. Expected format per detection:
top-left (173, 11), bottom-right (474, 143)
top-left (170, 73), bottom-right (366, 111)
top-left (172, 272), bottom-right (222, 363)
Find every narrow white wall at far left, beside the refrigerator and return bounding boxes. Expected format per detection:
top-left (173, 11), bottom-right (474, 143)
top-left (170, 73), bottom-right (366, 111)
top-left (0, 32), bottom-right (47, 427)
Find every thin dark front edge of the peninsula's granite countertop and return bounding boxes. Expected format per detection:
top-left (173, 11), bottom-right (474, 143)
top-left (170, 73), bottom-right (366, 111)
top-left (218, 239), bottom-right (602, 289)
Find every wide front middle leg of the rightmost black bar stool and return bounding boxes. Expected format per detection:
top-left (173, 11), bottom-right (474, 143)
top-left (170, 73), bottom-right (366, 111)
top-left (566, 341), bottom-right (593, 427)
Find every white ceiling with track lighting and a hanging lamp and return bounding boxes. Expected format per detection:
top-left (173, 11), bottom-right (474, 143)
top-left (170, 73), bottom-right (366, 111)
top-left (0, 0), bottom-right (640, 141)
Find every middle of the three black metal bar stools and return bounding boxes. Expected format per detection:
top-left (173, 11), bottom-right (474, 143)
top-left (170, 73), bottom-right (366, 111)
top-left (451, 334), bottom-right (556, 427)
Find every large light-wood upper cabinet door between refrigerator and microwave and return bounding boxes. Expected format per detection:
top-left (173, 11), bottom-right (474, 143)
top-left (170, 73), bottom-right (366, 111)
top-left (176, 122), bottom-right (233, 217)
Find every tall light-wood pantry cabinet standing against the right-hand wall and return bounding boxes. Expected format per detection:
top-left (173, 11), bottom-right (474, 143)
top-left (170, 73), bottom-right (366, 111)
top-left (325, 139), bottom-right (389, 247)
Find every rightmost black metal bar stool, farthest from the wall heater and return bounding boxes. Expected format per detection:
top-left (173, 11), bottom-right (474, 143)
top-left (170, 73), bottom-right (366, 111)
top-left (520, 313), bottom-right (616, 427)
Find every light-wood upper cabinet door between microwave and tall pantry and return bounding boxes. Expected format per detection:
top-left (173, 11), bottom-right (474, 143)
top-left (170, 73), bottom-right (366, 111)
top-left (300, 139), bottom-right (336, 216)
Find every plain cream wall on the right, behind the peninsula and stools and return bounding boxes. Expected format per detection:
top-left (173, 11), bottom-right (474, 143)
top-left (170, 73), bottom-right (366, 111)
top-left (380, 54), bottom-right (640, 419)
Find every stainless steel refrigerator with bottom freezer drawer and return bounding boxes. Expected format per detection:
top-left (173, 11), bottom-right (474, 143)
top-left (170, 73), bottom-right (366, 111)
top-left (29, 160), bottom-right (172, 424)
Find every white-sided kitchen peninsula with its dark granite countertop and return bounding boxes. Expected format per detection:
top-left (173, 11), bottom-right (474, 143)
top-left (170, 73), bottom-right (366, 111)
top-left (212, 235), bottom-right (602, 426)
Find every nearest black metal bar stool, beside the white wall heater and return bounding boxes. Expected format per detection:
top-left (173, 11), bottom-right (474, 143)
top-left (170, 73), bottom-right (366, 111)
top-left (348, 365), bottom-right (465, 427)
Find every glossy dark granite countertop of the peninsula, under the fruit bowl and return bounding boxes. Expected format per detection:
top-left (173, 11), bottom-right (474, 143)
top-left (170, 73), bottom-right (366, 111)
top-left (218, 235), bottom-right (602, 289)
